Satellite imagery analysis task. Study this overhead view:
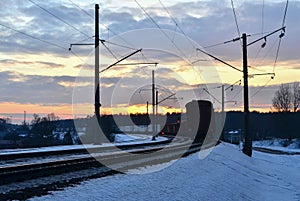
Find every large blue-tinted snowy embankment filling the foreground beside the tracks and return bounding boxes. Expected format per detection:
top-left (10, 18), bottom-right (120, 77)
top-left (32, 143), bottom-right (300, 201)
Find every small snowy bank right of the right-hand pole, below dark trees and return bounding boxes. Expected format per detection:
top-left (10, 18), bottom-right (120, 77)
top-left (253, 138), bottom-right (300, 154)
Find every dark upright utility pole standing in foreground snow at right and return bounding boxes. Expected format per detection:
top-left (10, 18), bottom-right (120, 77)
top-left (242, 33), bottom-right (252, 157)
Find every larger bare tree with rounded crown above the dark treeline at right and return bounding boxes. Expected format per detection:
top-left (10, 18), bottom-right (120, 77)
top-left (272, 84), bottom-right (293, 112)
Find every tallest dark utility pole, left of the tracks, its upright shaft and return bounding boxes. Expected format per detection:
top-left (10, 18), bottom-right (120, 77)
top-left (95, 4), bottom-right (101, 122)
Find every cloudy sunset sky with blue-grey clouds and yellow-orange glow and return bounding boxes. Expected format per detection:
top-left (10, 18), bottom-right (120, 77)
top-left (0, 0), bottom-right (300, 122)
